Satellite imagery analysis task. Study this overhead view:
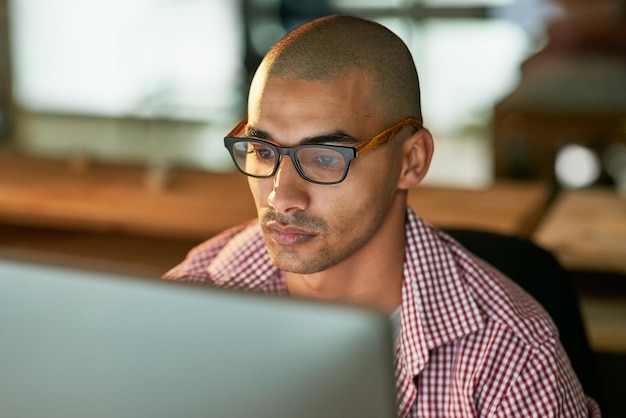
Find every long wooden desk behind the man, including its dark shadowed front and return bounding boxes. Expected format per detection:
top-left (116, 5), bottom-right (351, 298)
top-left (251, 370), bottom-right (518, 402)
top-left (0, 153), bottom-right (549, 276)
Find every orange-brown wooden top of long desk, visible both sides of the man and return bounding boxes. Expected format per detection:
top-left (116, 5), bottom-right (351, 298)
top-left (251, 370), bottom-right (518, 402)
top-left (0, 153), bottom-right (549, 240)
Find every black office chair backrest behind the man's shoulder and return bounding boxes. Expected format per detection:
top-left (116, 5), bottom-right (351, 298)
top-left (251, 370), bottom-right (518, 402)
top-left (445, 229), bottom-right (602, 404)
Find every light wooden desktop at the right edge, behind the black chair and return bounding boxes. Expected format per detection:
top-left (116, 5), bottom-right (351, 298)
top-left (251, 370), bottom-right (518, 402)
top-left (534, 188), bottom-right (626, 274)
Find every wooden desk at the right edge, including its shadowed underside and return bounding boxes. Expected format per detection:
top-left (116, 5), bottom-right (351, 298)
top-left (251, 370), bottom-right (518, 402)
top-left (533, 188), bottom-right (626, 353)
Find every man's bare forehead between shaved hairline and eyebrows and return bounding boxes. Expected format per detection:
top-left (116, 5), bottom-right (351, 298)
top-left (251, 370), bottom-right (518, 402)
top-left (248, 72), bottom-right (382, 142)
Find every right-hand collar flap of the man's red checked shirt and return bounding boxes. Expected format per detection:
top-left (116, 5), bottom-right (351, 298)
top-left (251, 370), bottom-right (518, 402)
top-left (400, 208), bottom-right (483, 376)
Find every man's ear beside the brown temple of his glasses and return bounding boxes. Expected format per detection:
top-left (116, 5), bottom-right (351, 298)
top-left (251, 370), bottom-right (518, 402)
top-left (398, 128), bottom-right (435, 189)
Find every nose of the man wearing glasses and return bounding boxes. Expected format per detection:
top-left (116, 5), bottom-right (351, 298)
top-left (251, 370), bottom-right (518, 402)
top-left (267, 156), bottom-right (310, 215)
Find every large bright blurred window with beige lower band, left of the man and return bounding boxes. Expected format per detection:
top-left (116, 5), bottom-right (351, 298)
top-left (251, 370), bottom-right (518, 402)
top-left (9, 0), bottom-right (244, 170)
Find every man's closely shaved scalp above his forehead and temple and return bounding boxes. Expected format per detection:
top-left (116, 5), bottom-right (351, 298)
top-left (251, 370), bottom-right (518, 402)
top-left (253, 16), bottom-right (422, 124)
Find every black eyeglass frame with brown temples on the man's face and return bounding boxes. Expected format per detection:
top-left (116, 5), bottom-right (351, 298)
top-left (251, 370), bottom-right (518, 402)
top-left (224, 117), bottom-right (423, 184)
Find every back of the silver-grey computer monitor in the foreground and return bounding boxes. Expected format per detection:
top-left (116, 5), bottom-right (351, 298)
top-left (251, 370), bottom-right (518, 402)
top-left (0, 260), bottom-right (396, 418)
